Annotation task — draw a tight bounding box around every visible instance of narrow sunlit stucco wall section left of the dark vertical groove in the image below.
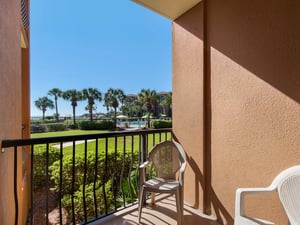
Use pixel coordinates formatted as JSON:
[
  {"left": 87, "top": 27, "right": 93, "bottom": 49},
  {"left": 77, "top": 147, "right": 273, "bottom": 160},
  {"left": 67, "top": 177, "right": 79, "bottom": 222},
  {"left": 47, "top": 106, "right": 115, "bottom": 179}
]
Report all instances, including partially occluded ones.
[{"left": 172, "top": 3, "right": 204, "bottom": 209}]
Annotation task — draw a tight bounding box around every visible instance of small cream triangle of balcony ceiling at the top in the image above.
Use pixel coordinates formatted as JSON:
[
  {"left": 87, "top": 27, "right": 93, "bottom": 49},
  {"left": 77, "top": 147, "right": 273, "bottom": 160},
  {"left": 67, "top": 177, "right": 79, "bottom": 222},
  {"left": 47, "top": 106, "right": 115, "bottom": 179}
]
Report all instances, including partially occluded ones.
[{"left": 132, "top": 0, "right": 202, "bottom": 20}]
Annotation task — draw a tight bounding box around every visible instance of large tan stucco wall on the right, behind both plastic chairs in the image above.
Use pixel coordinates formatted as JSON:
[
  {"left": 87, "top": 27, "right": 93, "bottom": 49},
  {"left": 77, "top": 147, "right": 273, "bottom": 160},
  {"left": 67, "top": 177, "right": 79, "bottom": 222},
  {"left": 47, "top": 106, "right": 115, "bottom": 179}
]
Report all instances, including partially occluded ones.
[{"left": 173, "top": 0, "right": 300, "bottom": 224}]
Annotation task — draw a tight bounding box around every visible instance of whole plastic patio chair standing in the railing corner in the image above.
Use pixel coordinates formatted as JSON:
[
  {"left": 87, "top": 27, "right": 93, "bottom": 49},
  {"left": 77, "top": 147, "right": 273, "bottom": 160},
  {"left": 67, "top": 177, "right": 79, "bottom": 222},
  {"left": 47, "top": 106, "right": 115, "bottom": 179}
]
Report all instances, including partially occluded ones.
[{"left": 138, "top": 141, "right": 186, "bottom": 224}]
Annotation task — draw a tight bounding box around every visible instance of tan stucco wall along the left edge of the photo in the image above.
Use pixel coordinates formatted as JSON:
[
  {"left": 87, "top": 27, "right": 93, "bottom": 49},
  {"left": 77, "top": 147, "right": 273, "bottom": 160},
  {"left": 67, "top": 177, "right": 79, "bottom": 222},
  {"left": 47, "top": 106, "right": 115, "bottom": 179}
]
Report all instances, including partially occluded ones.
[{"left": 0, "top": 0, "right": 30, "bottom": 224}]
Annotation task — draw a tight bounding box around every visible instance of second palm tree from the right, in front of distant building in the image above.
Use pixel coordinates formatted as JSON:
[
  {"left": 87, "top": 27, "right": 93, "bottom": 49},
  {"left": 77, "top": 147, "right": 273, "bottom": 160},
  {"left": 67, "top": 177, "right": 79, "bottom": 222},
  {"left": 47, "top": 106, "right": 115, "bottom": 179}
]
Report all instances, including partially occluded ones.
[{"left": 138, "top": 89, "right": 158, "bottom": 128}]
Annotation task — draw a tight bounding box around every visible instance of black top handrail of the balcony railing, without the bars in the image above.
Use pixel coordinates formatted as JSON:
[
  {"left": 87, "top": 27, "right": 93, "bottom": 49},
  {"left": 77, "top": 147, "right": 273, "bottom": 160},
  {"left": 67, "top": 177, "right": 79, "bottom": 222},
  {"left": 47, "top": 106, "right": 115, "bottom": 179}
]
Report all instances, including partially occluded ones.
[{"left": 1, "top": 128, "right": 172, "bottom": 149}]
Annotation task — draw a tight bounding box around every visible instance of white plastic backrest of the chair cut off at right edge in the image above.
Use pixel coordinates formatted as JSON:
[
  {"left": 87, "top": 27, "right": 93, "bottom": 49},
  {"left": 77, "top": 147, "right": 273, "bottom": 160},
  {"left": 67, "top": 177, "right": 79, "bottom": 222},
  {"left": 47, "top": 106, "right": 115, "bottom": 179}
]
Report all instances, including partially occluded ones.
[{"left": 275, "top": 166, "right": 300, "bottom": 225}]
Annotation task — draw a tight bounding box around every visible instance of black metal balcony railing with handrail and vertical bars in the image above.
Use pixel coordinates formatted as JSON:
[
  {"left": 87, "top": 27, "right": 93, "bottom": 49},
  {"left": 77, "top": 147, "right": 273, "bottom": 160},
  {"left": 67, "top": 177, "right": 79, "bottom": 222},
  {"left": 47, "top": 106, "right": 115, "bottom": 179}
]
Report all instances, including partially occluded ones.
[{"left": 1, "top": 128, "right": 172, "bottom": 225}]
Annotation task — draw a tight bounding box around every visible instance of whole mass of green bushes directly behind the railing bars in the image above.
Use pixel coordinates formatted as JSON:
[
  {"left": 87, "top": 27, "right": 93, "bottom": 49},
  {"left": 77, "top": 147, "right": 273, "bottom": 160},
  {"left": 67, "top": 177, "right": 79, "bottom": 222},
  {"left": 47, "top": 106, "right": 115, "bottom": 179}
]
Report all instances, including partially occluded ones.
[{"left": 34, "top": 145, "right": 138, "bottom": 222}]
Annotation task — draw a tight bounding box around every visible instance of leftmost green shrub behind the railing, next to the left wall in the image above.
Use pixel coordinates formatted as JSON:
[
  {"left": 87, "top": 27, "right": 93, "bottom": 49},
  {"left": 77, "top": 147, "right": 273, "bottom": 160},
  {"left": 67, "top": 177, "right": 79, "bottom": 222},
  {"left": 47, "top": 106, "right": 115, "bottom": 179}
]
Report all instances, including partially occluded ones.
[{"left": 33, "top": 145, "right": 60, "bottom": 190}]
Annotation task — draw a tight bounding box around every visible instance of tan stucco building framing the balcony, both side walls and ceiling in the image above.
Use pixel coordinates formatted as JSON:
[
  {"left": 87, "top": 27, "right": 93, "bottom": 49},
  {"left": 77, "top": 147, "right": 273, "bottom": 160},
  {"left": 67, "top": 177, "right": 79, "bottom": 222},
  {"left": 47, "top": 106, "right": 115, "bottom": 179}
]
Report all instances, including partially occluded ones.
[{"left": 0, "top": 0, "right": 300, "bottom": 225}]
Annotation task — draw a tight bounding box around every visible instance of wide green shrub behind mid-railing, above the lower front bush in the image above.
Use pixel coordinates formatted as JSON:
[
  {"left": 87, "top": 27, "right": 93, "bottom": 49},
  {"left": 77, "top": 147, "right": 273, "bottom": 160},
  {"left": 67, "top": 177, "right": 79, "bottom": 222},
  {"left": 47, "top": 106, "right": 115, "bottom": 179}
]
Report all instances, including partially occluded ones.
[{"left": 49, "top": 151, "right": 137, "bottom": 195}]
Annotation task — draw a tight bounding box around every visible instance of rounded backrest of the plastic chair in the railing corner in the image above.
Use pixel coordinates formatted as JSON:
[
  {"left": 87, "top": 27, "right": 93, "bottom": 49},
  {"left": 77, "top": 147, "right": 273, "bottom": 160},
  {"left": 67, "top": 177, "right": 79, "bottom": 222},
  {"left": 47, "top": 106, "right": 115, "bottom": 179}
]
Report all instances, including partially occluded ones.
[{"left": 148, "top": 141, "right": 186, "bottom": 179}]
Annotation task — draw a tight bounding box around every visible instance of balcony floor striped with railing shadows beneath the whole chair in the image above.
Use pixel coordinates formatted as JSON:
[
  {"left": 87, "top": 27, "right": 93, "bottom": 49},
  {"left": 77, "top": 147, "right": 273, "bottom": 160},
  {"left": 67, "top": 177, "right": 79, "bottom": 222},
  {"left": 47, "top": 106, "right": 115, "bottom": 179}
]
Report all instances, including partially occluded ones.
[{"left": 92, "top": 195, "right": 219, "bottom": 225}]
